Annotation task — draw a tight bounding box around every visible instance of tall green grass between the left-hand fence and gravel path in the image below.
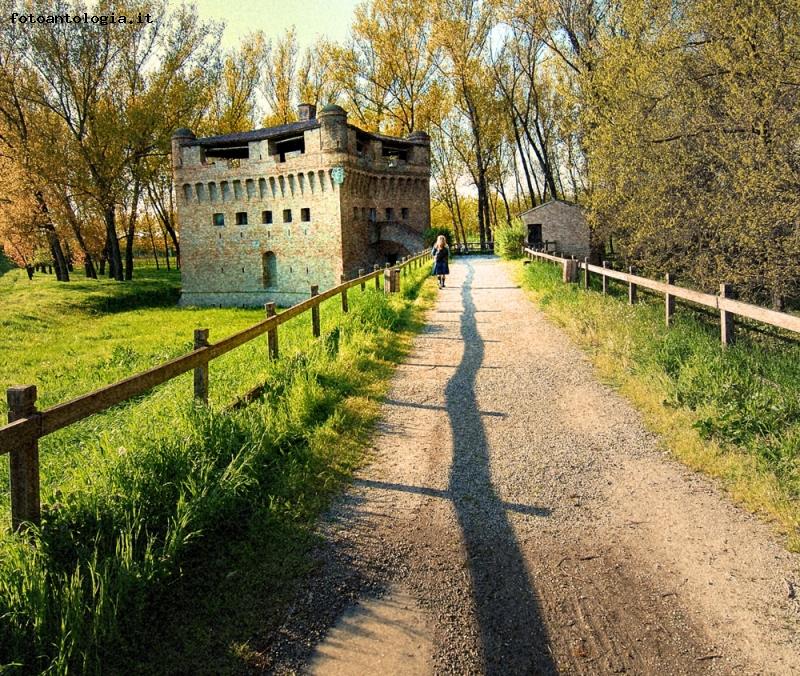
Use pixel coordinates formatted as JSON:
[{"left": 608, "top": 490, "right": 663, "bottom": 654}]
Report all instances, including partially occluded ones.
[{"left": 0, "top": 270, "right": 434, "bottom": 673}]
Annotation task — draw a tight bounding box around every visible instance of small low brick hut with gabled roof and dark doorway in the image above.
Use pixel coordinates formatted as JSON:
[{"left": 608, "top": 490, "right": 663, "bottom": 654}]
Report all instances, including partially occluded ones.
[{"left": 520, "top": 200, "right": 591, "bottom": 258}]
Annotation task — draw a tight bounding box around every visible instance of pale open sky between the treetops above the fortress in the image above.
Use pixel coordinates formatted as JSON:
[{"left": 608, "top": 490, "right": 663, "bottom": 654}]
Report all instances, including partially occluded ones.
[{"left": 184, "top": 0, "right": 358, "bottom": 51}]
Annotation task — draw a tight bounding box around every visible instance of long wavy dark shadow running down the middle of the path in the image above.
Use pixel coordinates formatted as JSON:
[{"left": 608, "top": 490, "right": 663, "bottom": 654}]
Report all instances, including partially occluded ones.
[{"left": 445, "top": 261, "right": 557, "bottom": 674}]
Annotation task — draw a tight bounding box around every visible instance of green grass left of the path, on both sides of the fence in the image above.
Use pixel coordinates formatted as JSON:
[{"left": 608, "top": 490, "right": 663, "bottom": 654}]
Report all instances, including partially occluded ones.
[{"left": 0, "top": 268, "right": 438, "bottom": 673}]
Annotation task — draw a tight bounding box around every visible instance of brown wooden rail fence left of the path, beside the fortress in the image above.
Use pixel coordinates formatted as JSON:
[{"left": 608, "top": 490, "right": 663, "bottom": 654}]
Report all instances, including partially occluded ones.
[{"left": 0, "top": 251, "right": 429, "bottom": 530}]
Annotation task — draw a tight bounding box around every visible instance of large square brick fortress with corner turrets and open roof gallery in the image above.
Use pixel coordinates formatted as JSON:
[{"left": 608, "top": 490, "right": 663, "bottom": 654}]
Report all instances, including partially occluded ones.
[{"left": 172, "top": 104, "right": 430, "bottom": 306}]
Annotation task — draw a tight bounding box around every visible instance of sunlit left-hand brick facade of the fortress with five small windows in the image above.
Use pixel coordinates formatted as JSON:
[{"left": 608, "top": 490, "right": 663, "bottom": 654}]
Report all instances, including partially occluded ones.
[{"left": 177, "top": 145, "right": 341, "bottom": 306}]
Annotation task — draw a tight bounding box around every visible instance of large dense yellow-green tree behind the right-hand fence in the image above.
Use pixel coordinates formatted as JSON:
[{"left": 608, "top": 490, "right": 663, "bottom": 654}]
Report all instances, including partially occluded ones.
[{"left": 583, "top": 0, "right": 800, "bottom": 304}]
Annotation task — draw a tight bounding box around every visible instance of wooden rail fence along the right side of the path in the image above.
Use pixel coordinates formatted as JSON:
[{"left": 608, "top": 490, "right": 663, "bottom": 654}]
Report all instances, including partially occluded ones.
[{"left": 523, "top": 248, "right": 800, "bottom": 346}]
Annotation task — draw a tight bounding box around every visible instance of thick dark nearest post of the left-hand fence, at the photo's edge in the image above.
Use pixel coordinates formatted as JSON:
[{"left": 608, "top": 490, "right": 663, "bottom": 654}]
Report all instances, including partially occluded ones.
[{"left": 6, "top": 385, "right": 41, "bottom": 532}]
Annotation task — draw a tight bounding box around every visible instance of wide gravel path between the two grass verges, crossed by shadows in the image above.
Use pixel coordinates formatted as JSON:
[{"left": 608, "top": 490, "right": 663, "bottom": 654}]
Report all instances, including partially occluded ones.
[{"left": 262, "top": 258, "right": 800, "bottom": 674}]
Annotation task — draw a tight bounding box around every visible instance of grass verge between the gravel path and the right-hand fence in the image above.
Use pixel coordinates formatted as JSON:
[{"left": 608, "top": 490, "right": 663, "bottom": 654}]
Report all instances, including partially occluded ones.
[{"left": 515, "top": 263, "right": 800, "bottom": 551}]
